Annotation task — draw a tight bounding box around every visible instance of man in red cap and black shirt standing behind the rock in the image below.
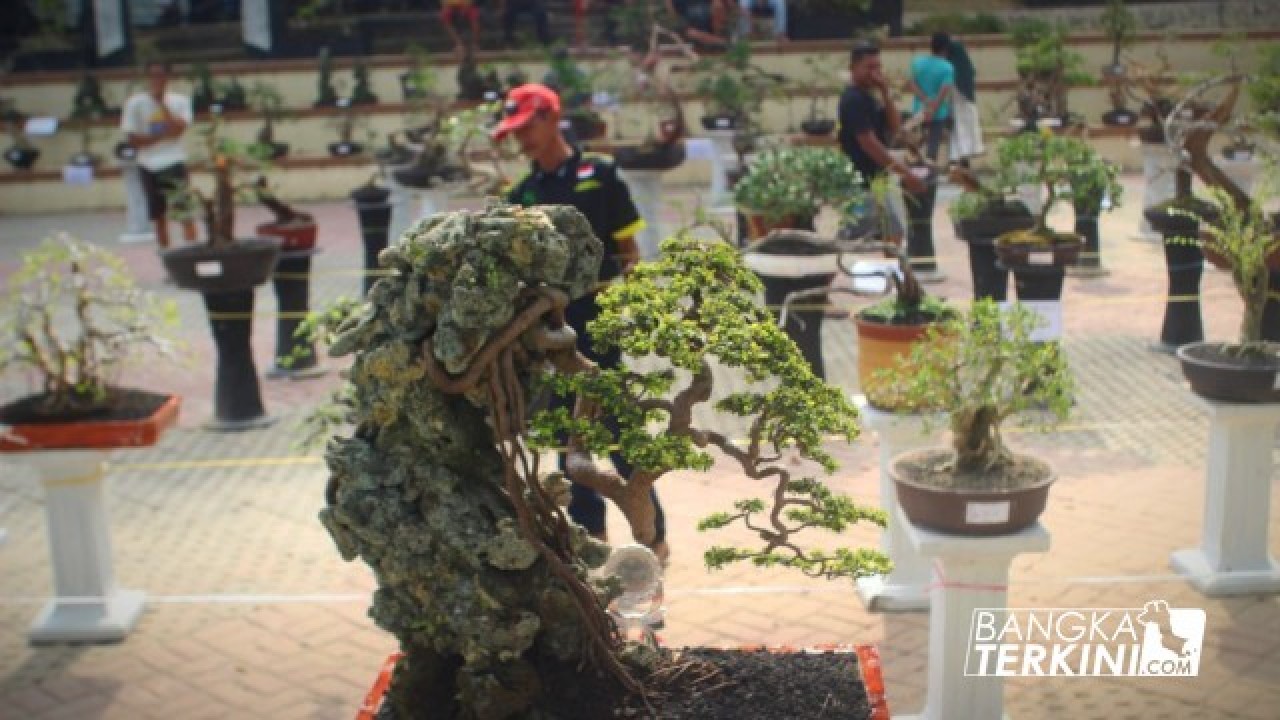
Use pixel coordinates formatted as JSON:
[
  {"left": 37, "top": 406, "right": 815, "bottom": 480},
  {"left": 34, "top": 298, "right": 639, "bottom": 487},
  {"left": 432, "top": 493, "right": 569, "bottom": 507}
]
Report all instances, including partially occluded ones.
[{"left": 493, "top": 83, "right": 669, "bottom": 562}]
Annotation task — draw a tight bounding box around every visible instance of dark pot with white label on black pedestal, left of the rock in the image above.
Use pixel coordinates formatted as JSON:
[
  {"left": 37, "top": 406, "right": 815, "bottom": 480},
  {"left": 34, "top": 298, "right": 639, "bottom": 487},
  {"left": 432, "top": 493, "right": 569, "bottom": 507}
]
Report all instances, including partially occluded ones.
[{"left": 160, "top": 237, "right": 280, "bottom": 292}]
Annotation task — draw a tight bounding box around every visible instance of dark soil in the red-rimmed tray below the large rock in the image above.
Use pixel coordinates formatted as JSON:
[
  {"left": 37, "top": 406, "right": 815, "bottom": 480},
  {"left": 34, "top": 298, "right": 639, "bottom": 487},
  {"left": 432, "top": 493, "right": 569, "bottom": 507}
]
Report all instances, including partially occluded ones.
[{"left": 376, "top": 648, "right": 870, "bottom": 720}]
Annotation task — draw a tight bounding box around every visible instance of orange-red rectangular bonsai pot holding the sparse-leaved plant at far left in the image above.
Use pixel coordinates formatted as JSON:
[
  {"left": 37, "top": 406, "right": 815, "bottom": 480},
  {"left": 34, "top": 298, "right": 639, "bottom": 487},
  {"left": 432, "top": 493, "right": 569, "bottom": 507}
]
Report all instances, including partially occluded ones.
[{"left": 0, "top": 388, "right": 182, "bottom": 452}]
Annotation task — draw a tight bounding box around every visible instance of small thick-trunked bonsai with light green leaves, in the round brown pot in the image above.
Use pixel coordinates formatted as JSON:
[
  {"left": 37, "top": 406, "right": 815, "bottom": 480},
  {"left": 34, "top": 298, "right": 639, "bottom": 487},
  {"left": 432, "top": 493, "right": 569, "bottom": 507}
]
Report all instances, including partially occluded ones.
[{"left": 883, "top": 299, "right": 1074, "bottom": 479}]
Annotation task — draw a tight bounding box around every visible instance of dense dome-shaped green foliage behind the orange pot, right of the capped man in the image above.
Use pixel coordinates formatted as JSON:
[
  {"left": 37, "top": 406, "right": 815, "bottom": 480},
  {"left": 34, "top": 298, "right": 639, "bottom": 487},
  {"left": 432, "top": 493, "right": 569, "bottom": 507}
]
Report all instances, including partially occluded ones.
[{"left": 733, "top": 147, "right": 863, "bottom": 227}]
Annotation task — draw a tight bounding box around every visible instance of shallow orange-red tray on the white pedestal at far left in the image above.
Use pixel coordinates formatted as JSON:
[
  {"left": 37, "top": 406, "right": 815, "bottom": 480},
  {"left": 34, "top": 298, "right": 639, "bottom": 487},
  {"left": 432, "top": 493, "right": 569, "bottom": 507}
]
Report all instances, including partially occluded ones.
[{"left": 0, "top": 391, "right": 182, "bottom": 452}]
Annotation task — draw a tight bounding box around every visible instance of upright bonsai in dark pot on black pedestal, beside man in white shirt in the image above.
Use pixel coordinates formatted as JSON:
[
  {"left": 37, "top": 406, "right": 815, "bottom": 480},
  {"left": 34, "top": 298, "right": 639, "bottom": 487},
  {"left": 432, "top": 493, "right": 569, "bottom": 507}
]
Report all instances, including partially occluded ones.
[{"left": 160, "top": 115, "right": 280, "bottom": 430}]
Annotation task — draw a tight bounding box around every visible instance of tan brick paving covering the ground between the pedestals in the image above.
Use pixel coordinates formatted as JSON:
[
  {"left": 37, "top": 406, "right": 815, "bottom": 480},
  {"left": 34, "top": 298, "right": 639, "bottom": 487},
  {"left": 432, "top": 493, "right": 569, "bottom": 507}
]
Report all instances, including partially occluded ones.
[{"left": 0, "top": 178, "right": 1280, "bottom": 720}]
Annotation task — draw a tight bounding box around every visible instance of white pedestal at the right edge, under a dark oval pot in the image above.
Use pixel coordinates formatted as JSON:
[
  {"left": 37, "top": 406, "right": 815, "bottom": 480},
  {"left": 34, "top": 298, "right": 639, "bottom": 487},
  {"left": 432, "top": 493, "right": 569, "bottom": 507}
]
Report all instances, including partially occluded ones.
[{"left": 1170, "top": 396, "right": 1280, "bottom": 596}]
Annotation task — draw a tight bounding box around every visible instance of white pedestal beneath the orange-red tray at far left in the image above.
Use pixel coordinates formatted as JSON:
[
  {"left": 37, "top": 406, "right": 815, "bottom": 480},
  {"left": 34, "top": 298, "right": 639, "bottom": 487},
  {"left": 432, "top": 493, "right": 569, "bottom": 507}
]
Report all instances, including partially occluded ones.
[{"left": 13, "top": 450, "right": 146, "bottom": 643}]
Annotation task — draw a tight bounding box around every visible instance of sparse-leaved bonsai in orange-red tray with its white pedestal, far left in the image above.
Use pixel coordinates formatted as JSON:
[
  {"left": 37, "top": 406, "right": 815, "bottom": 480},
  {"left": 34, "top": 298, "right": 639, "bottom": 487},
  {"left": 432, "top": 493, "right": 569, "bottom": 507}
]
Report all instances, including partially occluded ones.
[{"left": 0, "top": 234, "right": 180, "bottom": 643}]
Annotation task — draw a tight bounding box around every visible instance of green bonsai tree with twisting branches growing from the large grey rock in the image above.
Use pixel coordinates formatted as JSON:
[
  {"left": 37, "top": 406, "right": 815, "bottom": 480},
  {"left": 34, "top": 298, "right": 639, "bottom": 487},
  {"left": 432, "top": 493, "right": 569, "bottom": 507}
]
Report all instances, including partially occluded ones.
[{"left": 531, "top": 234, "right": 888, "bottom": 578}]
